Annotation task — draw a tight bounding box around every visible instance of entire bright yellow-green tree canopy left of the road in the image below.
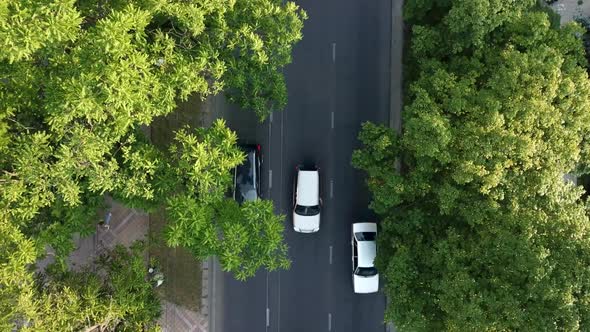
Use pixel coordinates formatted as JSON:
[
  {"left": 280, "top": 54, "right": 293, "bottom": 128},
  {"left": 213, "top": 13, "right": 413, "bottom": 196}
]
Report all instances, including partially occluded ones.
[{"left": 0, "top": 0, "right": 296, "bottom": 331}]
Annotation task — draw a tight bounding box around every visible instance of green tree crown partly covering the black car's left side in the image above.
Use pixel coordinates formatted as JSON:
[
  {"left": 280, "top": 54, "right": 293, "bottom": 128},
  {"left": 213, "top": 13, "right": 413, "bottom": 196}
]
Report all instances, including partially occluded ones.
[{"left": 166, "top": 120, "right": 290, "bottom": 280}]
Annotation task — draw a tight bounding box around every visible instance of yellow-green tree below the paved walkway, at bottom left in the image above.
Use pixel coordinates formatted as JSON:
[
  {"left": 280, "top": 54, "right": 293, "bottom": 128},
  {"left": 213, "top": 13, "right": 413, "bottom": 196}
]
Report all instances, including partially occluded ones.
[{"left": 27, "top": 242, "right": 161, "bottom": 331}]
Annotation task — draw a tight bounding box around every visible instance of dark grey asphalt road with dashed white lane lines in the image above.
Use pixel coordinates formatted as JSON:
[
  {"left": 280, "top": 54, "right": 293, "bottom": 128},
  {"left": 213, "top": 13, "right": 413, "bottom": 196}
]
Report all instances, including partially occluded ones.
[{"left": 220, "top": 0, "right": 392, "bottom": 332}]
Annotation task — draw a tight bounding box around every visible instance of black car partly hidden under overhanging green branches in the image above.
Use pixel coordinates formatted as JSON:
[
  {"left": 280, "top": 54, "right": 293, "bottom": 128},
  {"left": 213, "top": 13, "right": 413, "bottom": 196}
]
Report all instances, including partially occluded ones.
[{"left": 233, "top": 144, "right": 262, "bottom": 204}]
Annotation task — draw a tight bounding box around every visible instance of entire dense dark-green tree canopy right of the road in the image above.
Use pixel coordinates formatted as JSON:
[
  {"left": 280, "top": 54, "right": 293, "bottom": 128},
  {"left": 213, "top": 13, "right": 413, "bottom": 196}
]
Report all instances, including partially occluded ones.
[{"left": 353, "top": 1, "right": 590, "bottom": 331}]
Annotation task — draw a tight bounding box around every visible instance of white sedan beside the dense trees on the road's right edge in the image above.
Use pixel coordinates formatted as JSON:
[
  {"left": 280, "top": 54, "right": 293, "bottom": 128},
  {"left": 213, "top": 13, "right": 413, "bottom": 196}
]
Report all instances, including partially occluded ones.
[{"left": 351, "top": 222, "right": 379, "bottom": 294}]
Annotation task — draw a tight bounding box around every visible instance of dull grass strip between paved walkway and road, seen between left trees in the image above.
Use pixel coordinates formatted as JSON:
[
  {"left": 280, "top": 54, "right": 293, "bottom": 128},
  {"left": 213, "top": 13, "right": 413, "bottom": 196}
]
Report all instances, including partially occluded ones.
[{"left": 149, "top": 96, "right": 203, "bottom": 311}]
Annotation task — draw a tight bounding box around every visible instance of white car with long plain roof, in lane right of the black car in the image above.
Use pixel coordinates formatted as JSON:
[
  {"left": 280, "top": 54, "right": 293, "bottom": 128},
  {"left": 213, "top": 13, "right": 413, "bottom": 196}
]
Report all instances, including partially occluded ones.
[{"left": 293, "top": 167, "right": 322, "bottom": 233}]
